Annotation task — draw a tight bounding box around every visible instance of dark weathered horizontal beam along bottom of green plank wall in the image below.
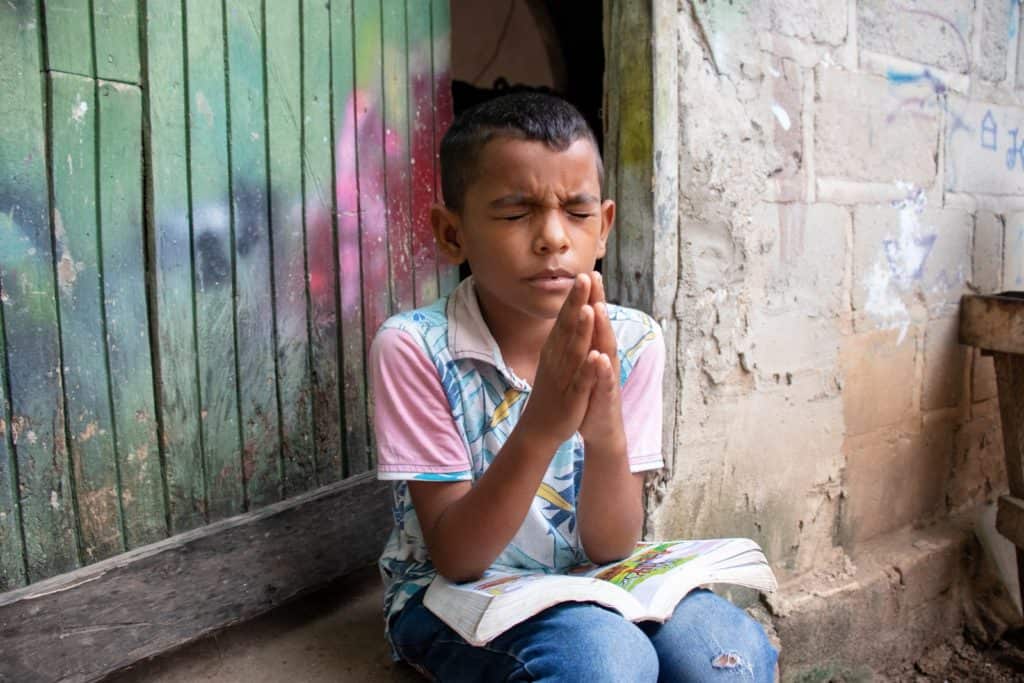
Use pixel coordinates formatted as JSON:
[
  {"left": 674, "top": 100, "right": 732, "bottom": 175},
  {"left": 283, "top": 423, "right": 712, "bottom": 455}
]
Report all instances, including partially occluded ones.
[{"left": 0, "top": 474, "right": 391, "bottom": 683}]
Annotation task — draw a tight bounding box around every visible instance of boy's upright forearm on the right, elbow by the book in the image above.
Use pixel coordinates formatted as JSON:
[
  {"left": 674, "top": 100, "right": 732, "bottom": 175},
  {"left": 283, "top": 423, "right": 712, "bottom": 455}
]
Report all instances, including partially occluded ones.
[{"left": 577, "top": 437, "right": 643, "bottom": 564}]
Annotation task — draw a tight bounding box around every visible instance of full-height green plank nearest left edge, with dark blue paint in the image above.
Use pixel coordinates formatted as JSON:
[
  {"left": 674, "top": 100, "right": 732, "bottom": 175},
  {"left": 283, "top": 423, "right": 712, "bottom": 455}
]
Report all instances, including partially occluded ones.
[{"left": 0, "top": 2, "right": 79, "bottom": 582}]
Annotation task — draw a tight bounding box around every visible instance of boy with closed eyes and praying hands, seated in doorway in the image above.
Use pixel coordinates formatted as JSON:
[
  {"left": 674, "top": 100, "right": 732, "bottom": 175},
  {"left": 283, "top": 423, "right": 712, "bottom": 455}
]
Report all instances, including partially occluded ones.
[{"left": 371, "top": 93, "right": 775, "bottom": 683}]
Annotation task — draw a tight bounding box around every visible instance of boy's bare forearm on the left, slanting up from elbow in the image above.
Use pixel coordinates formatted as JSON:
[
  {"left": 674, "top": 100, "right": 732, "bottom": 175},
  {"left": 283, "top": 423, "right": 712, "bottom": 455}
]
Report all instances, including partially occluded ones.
[{"left": 414, "top": 423, "right": 558, "bottom": 581}]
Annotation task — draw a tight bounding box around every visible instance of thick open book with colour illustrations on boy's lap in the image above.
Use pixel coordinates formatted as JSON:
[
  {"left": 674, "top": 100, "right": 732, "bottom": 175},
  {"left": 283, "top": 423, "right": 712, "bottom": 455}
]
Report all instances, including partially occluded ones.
[{"left": 423, "top": 539, "right": 776, "bottom": 645}]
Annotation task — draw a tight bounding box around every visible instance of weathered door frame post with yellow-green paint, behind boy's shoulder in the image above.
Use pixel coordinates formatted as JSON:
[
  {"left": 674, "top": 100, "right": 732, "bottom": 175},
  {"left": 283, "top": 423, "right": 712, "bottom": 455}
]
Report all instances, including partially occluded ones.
[{"left": 604, "top": 0, "right": 682, "bottom": 518}]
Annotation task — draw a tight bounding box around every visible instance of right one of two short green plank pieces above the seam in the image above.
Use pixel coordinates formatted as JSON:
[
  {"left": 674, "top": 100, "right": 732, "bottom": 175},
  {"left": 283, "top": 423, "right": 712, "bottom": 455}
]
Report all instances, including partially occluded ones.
[{"left": 92, "top": 0, "right": 140, "bottom": 83}]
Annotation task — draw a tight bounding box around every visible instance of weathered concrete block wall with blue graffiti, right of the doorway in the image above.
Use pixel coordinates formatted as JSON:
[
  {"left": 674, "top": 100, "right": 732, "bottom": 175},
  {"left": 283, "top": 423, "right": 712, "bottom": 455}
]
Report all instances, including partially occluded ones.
[{"left": 650, "top": 0, "right": 1024, "bottom": 580}]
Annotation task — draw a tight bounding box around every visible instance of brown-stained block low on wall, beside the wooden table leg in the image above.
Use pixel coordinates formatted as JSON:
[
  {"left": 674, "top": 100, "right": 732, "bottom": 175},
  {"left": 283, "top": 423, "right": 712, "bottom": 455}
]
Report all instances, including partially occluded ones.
[{"left": 947, "top": 415, "right": 1007, "bottom": 510}]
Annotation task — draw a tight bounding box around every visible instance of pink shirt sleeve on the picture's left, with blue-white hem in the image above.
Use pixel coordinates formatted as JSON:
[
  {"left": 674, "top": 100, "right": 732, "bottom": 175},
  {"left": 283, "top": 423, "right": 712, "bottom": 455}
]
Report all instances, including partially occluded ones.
[{"left": 370, "top": 329, "right": 472, "bottom": 481}]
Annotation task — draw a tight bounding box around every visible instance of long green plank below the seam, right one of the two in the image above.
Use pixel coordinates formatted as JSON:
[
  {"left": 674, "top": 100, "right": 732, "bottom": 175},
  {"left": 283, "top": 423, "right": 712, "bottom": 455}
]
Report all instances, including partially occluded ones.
[{"left": 99, "top": 82, "right": 168, "bottom": 548}]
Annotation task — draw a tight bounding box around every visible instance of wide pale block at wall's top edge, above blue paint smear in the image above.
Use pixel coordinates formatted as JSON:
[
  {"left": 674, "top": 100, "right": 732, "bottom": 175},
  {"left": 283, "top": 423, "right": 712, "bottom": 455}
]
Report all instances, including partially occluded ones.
[{"left": 857, "top": 0, "right": 974, "bottom": 74}]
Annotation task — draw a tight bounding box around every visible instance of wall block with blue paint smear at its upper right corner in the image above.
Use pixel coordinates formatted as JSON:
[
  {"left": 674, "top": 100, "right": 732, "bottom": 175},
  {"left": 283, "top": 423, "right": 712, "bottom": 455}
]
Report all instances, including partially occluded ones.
[{"left": 814, "top": 68, "right": 940, "bottom": 187}]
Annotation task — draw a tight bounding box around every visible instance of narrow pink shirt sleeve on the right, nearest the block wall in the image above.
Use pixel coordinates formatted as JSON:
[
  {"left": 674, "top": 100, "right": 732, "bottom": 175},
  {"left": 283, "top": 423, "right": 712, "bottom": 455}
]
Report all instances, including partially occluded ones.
[{"left": 623, "top": 335, "right": 665, "bottom": 472}]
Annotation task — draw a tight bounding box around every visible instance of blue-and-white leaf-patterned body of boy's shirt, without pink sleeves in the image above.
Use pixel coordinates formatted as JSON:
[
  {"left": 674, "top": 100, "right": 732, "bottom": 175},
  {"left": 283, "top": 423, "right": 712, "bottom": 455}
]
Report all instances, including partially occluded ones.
[{"left": 378, "top": 278, "right": 662, "bottom": 634}]
